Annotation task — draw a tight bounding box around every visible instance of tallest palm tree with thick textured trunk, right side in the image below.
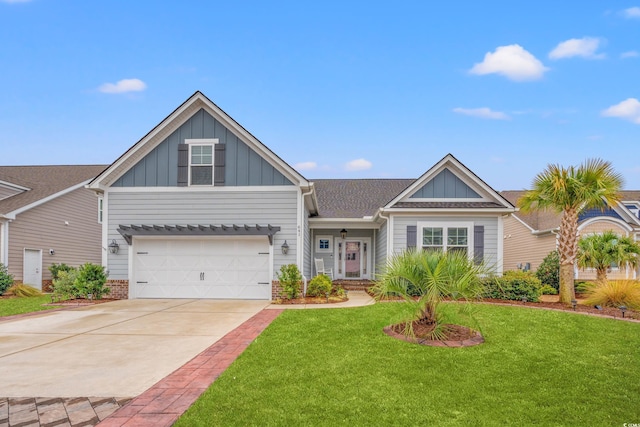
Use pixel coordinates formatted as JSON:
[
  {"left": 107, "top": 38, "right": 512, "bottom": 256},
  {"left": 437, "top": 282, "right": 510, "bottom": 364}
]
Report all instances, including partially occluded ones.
[{"left": 518, "top": 159, "right": 623, "bottom": 304}]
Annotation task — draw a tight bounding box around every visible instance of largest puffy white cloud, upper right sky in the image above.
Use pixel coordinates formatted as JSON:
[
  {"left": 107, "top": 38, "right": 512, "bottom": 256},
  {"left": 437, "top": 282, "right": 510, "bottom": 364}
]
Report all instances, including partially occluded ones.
[{"left": 469, "top": 44, "right": 549, "bottom": 81}]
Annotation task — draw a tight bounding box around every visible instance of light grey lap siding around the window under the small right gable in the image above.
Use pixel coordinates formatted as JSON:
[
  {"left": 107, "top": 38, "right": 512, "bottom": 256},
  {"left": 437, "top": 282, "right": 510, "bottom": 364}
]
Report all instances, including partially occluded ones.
[{"left": 393, "top": 215, "right": 502, "bottom": 265}]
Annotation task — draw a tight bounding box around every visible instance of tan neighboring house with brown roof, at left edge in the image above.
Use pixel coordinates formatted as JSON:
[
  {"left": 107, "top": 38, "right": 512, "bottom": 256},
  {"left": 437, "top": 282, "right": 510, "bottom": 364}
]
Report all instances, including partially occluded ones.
[{"left": 0, "top": 165, "right": 106, "bottom": 289}]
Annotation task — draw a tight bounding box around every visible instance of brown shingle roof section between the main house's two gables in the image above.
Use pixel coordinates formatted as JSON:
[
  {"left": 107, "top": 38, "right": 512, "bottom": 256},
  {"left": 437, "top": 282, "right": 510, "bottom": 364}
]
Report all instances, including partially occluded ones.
[{"left": 310, "top": 179, "right": 415, "bottom": 218}]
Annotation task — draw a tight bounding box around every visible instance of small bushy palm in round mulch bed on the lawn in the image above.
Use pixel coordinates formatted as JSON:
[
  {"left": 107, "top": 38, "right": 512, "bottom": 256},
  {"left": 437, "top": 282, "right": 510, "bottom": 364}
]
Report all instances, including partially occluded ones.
[{"left": 374, "top": 250, "right": 486, "bottom": 339}]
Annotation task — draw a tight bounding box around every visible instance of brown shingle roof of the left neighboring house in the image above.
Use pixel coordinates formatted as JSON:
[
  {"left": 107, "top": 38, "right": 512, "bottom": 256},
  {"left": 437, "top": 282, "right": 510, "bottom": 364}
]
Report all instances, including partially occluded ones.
[{"left": 0, "top": 165, "right": 107, "bottom": 215}]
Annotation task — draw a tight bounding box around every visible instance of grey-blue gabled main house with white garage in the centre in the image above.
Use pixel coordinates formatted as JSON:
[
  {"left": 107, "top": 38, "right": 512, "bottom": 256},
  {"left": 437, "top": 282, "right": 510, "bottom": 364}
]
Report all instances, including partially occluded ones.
[{"left": 88, "top": 92, "right": 514, "bottom": 299}]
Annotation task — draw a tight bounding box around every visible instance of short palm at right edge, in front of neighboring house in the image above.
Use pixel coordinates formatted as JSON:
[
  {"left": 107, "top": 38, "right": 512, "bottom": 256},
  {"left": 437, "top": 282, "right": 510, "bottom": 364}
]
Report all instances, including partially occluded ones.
[{"left": 577, "top": 230, "right": 640, "bottom": 281}]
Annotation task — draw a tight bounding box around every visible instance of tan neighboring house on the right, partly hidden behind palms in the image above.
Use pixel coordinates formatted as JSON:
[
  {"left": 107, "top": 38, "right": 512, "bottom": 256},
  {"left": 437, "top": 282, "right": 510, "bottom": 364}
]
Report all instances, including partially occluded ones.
[{"left": 500, "top": 191, "right": 640, "bottom": 280}]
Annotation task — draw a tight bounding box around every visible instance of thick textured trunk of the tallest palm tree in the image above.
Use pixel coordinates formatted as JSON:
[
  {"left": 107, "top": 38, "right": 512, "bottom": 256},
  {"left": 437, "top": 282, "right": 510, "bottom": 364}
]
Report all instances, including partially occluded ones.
[{"left": 558, "top": 207, "right": 578, "bottom": 304}]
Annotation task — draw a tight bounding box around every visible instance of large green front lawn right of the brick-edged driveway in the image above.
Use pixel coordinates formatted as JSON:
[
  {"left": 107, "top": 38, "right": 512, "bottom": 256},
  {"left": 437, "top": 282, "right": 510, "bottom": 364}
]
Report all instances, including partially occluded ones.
[{"left": 176, "top": 303, "right": 640, "bottom": 426}]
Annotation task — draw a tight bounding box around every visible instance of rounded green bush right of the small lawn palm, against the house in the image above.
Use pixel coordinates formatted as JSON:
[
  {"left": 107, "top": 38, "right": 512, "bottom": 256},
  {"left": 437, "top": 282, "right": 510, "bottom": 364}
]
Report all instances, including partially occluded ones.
[{"left": 482, "top": 270, "right": 542, "bottom": 302}]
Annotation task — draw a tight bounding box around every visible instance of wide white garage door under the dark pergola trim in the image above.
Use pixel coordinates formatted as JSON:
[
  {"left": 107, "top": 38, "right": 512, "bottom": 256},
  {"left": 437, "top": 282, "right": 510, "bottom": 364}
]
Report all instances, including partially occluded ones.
[{"left": 131, "top": 236, "right": 271, "bottom": 299}]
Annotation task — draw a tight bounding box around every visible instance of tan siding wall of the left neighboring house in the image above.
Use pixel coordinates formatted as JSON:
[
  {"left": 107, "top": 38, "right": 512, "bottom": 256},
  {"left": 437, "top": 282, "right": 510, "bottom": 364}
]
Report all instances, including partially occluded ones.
[{"left": 9, "top": 188, "right": 102, "bottom": 280}]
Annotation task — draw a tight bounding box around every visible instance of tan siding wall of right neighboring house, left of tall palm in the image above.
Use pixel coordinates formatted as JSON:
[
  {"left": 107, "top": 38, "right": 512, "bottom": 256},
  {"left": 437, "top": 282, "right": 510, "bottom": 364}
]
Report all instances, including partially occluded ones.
[{"left": 503, "top": 216, "right": 556, "bottom": 271}]
